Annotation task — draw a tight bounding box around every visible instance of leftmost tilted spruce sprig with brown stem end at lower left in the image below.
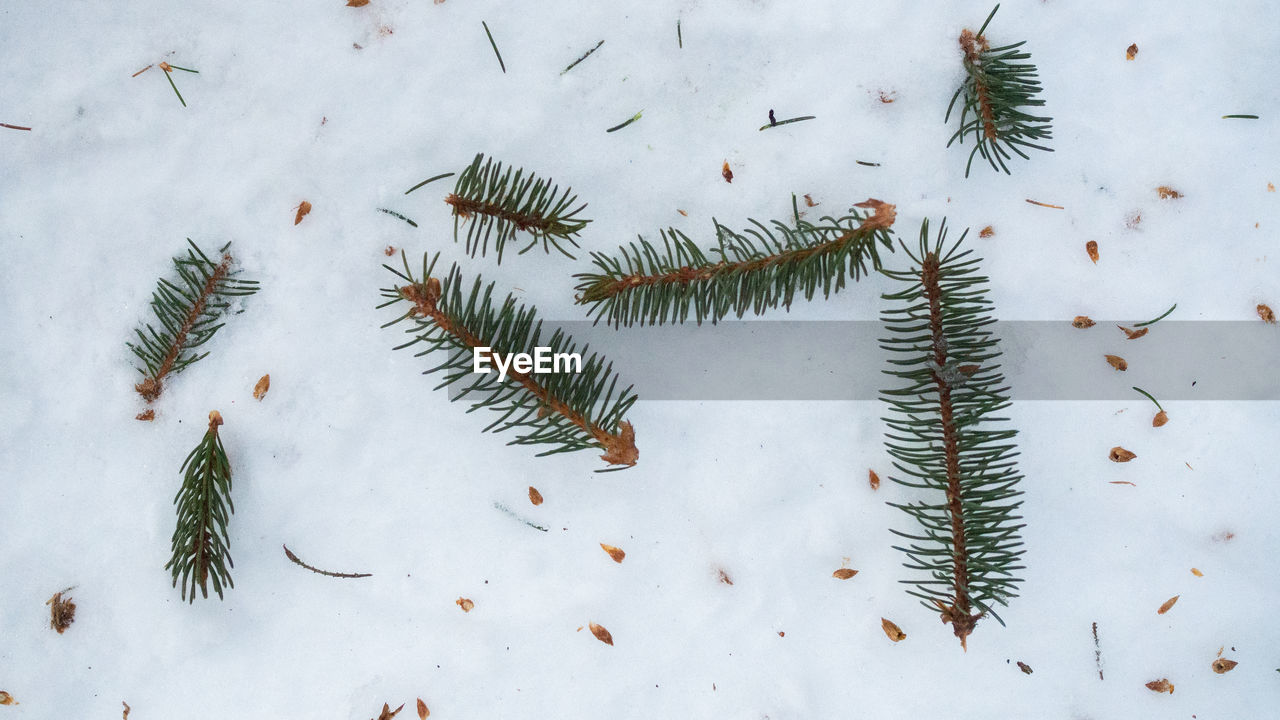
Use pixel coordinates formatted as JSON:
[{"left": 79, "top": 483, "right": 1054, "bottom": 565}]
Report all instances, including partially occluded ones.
[{"left": 125, "top": 238, "right": 257, "bottom": 402}]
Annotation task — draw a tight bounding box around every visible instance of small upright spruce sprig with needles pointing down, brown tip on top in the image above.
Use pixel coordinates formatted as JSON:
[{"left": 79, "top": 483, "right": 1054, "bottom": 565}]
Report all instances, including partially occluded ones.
[{"left": 164, "top": 410, "right": 236, "bottom": 602}]
